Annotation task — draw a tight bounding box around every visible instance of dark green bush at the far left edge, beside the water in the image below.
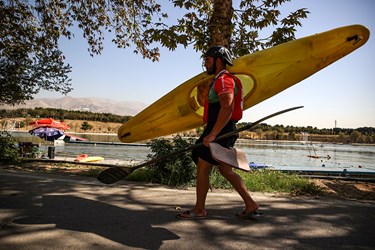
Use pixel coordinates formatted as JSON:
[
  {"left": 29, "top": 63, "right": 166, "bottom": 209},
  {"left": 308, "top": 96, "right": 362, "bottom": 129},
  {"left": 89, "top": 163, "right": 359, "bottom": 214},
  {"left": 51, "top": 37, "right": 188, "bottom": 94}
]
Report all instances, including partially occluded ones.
[{"left": 0, "top": 131, "right": 19, "bottom": 163}]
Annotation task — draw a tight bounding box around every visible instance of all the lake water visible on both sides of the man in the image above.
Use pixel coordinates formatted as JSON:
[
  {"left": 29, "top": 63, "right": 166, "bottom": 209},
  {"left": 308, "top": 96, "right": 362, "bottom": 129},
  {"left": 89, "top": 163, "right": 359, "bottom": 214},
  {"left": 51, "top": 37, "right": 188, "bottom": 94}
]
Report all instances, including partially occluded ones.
[{"left": 9, "top": 133, "right": 375, "bottom": 170}]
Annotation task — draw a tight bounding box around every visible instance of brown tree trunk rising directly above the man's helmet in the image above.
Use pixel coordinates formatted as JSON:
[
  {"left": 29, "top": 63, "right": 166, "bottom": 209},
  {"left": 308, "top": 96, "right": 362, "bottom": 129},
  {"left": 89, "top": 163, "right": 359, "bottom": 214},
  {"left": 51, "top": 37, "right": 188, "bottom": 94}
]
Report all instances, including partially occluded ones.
[{"left": 208, "top": 0, "right": 233, "bottom": 48}]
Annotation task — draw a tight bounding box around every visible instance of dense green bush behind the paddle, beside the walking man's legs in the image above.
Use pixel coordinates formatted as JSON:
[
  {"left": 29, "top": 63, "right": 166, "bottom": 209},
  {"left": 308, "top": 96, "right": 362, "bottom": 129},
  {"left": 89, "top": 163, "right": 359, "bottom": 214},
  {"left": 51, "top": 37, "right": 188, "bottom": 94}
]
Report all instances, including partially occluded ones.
[{"left": 148, "top": 136, "right": 196, "bottom": 187}]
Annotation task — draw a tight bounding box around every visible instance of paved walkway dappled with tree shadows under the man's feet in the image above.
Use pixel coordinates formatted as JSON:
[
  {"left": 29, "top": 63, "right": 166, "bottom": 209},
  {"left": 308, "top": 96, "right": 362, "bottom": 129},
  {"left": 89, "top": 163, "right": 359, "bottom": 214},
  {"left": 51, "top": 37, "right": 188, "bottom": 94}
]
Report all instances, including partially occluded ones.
[{"left": 0, "top": 169, "right": 375, "bottom": 250}]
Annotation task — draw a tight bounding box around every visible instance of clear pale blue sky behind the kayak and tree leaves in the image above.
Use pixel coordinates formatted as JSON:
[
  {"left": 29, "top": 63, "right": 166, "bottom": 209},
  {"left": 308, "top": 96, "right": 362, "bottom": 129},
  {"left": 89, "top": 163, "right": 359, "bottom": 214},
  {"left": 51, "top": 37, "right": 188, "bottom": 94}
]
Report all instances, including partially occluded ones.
[{"left": 36, "top": 0, "right": 375, "bottom": 128}]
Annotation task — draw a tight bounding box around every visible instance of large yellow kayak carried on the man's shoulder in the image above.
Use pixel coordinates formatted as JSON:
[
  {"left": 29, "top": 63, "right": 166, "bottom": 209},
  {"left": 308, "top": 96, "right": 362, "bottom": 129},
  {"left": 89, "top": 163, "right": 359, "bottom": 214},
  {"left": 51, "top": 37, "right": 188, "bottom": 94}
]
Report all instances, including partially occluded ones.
[{"left": 118, "top": 25, "right": 370, "bottom": 143}]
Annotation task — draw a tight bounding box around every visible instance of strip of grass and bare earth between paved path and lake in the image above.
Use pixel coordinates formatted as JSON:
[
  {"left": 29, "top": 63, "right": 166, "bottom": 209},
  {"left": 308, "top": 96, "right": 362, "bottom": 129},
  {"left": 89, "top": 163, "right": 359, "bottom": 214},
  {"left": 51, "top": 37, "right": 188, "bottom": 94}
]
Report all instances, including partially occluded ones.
[{"left": 0, "top": 162, "right": 375, "bottom": 201}]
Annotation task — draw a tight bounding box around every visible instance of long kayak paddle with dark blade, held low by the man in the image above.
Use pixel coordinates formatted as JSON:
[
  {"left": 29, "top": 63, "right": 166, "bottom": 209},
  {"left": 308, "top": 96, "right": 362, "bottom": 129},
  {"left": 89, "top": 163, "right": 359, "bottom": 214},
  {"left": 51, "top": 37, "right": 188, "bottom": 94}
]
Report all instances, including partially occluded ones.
[{"left": 96, "top": 106, "right": 303, "bottom": 184}]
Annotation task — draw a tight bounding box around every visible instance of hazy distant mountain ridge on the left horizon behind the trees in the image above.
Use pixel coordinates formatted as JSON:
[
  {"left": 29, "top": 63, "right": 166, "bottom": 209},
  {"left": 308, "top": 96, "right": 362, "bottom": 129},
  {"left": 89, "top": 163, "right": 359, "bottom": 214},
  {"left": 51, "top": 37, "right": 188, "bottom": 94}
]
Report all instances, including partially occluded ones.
[{"left": 0, "top": 96, "right": 148, "bottom": 116}]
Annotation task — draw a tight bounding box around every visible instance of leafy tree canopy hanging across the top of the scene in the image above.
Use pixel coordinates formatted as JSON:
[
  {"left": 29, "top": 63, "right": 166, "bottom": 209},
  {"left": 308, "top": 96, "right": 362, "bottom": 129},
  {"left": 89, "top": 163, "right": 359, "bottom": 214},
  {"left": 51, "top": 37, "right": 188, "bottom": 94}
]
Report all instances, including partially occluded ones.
[{"left": 0, "top": 0, "right": 308, "bottom": 105}]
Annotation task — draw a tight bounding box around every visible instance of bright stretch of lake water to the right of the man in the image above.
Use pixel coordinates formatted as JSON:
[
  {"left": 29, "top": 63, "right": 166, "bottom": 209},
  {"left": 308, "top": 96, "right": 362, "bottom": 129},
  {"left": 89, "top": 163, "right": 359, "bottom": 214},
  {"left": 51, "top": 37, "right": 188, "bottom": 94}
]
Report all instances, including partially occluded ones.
[{"left": 237, "top": 141, "right": 375, "bottom": 170}]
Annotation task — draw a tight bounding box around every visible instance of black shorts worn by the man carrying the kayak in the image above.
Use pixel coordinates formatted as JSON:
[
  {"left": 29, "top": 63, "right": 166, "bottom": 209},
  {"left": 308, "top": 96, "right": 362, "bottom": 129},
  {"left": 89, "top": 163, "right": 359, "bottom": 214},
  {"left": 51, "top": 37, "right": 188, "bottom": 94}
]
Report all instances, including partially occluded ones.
[{"left": 192, "top": 121, "right": 238, "bottom": 165}]
